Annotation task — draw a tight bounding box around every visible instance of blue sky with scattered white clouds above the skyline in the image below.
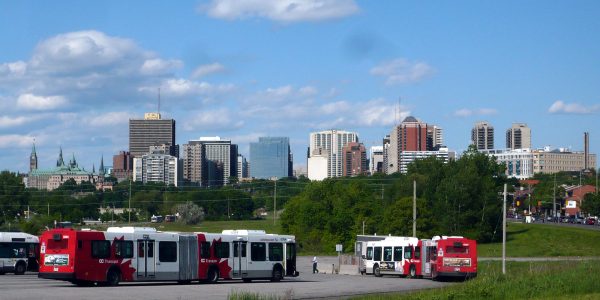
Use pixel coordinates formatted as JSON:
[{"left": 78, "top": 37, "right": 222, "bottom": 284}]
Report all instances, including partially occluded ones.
[{"left": 0, "top": 0, "right": 600, "bottom": 172}]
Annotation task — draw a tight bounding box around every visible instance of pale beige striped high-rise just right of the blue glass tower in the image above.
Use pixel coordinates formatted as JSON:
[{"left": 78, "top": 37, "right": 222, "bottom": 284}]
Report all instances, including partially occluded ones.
[{"left": 310, "top": 130, "right": 358, "bottom": 179}]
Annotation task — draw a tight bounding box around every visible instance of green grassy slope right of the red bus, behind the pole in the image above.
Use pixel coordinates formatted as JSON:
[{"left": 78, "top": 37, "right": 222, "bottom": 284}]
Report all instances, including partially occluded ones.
[{"left": 477, "top": 223, "right": 600, "bottom": 257}]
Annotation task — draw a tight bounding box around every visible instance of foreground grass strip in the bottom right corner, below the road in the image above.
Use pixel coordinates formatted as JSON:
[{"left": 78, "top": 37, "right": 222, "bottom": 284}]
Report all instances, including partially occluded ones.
[{"left": 356, "top": 261, "right": 600, "bottom": 300}]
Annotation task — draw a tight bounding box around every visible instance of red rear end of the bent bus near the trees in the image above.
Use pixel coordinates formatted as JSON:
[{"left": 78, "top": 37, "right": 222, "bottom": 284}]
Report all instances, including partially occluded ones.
[{"left": 432, "top": 237, "right": 477, "bottom": 278}]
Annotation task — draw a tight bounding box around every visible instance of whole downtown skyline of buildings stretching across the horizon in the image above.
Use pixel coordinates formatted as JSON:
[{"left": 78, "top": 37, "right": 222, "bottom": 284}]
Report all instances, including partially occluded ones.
[{"left": 24, "top": 113, "right": 596, "bottom": 190}]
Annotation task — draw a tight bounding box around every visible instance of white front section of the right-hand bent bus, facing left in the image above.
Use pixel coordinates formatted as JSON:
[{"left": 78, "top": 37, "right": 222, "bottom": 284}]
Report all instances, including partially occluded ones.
[{"left": 363, "top": 236, "right": 421, "bottom": 277}]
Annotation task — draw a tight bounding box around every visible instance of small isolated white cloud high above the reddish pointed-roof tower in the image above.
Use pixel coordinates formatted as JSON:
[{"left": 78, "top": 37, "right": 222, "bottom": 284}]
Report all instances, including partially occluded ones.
[{"left": 369, "top": 58, "right": 435, "bottom": 85}]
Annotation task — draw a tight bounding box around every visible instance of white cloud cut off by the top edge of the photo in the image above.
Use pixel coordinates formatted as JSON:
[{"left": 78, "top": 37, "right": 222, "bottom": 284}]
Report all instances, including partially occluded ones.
[{"left": 201, "top": 0, "right": 359, "bottom": 23}]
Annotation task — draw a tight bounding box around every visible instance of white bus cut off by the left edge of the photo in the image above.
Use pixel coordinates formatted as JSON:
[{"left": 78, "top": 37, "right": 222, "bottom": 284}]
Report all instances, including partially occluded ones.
[{"left": 0, "top": 232, "right": 39, "bottom": 275}]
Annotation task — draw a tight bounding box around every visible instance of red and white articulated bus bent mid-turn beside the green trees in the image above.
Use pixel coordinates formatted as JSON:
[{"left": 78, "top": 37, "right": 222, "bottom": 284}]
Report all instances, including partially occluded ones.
[{"left": 361, "top": 236, "right": 477, "bottom": 280}]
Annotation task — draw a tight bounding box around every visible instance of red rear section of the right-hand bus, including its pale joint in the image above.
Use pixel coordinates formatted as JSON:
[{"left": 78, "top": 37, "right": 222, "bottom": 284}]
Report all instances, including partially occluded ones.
[{"left": 421, "top": 236, "right": 477, "bottom": 279}]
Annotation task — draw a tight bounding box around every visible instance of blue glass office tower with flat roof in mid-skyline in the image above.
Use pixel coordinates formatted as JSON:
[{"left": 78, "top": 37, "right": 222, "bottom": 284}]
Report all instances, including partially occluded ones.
[{"left": 250, "top": 137, "right": 293, "bottom": 179}]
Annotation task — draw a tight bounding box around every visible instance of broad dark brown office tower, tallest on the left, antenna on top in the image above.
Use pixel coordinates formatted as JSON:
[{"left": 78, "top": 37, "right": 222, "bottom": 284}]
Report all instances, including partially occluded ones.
[{"left": 129, "top": 113, "right": 179, "bottom": 157}]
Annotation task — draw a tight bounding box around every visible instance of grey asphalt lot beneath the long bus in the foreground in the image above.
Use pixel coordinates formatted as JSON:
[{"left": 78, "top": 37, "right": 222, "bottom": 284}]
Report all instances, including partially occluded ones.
[{"left": 0, "top": 257, "right": 450, "bottom": 300}]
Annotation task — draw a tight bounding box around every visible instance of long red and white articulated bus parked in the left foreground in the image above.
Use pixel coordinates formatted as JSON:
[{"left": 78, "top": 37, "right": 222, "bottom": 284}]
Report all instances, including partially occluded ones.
[{"left": 38, "top": 227, "right": 298, "bottom": 285}]
